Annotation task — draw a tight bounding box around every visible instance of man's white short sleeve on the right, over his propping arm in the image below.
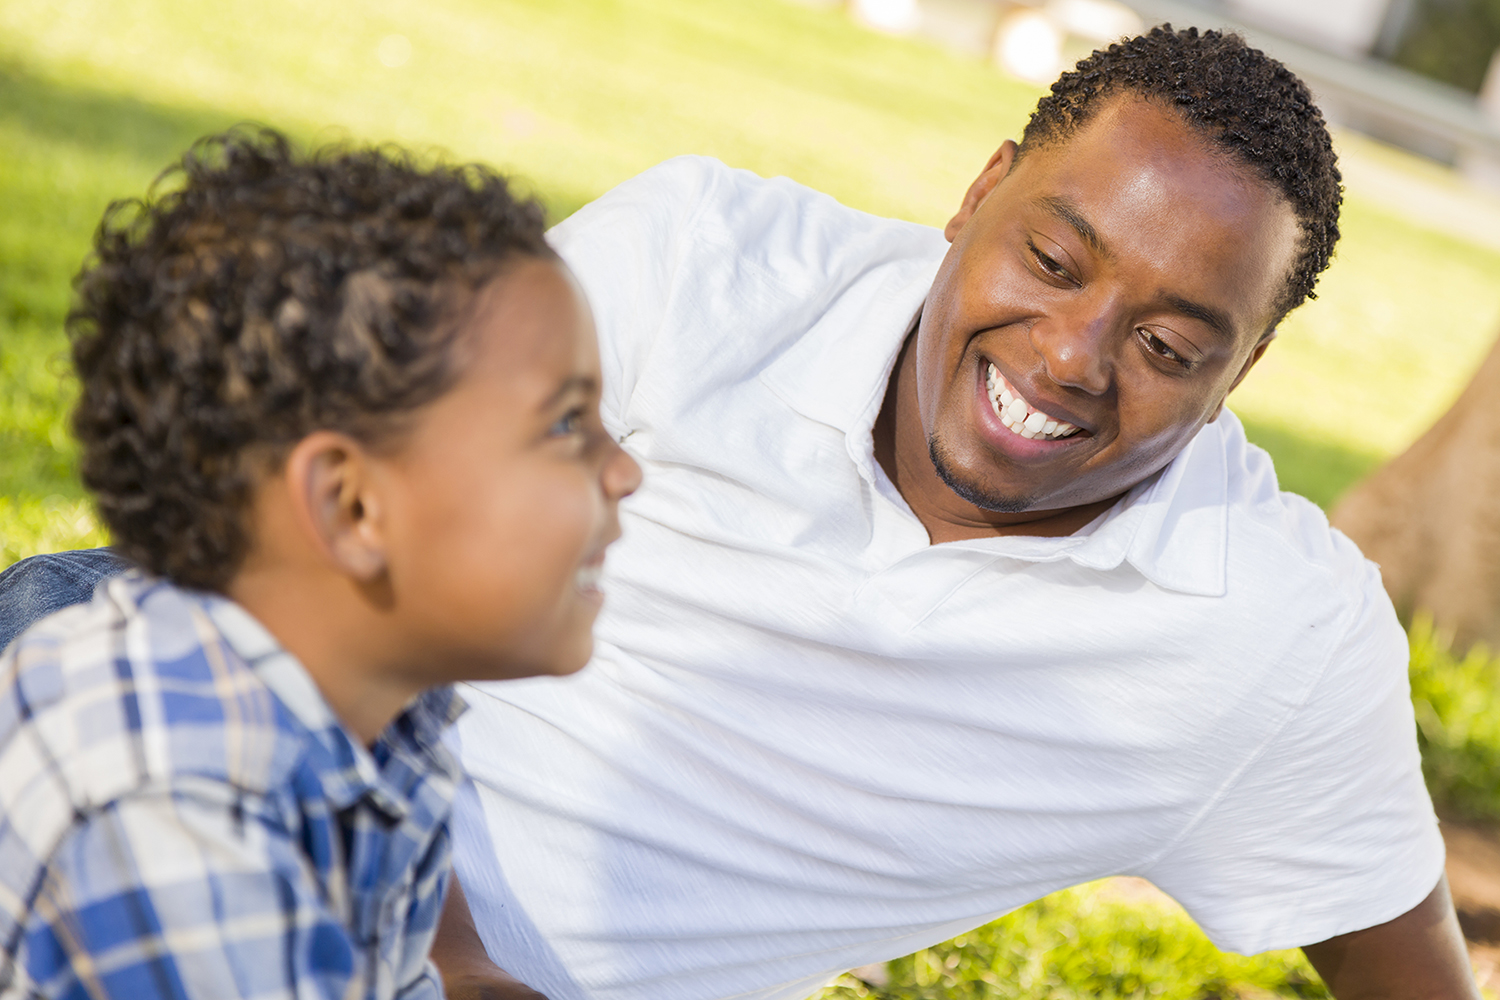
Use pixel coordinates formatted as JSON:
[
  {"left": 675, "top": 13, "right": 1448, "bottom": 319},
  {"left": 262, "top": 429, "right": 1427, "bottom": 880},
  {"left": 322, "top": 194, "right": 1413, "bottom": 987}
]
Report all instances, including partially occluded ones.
[{"left": 1143, "top": 560, "right": 1445, "bottom": 954}]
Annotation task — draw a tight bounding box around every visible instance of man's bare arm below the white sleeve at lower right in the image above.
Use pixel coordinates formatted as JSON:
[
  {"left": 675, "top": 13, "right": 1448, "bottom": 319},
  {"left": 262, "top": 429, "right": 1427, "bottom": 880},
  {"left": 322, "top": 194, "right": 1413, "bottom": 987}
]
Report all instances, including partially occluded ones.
[{"left": 1302, "top": 876, "right": 1479, "bottom": 1000}]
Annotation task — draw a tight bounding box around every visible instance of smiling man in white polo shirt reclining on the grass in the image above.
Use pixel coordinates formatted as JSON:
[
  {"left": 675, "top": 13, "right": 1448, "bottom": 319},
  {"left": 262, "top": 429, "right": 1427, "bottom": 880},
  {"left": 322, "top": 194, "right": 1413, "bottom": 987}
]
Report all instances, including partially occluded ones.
[{"left": 0, "top": 28, "right": 1478, "bottom": 1000}]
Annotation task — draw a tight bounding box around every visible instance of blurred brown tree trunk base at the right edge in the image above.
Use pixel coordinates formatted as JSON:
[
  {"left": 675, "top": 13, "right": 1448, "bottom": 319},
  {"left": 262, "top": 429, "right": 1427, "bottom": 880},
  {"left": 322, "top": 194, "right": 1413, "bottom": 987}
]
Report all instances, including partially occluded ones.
[{"left": 1332, "top": 332, "right": 1500, "bottom": 651}]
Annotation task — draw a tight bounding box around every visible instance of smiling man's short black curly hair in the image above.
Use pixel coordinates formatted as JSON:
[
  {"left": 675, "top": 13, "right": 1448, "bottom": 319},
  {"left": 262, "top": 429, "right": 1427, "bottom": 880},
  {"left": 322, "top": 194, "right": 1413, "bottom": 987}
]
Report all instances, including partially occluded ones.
[{"left": 1022, "top": 24, "right": 1343, "bottom": 322}]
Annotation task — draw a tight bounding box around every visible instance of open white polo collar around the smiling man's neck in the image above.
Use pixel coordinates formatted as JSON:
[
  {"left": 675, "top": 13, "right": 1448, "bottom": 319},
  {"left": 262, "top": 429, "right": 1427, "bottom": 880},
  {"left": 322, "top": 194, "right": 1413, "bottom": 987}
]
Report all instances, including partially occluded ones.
[{"left": 761, "top": 255, "right": 1244, "bottom": 597}]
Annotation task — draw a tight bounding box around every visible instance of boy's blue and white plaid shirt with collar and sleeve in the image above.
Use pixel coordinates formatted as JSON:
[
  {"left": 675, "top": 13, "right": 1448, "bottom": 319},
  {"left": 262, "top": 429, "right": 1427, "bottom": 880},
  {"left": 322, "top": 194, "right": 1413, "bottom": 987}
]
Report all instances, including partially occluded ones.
[{"left": 0, "top": 573, "right": 464, "bottom": 999}]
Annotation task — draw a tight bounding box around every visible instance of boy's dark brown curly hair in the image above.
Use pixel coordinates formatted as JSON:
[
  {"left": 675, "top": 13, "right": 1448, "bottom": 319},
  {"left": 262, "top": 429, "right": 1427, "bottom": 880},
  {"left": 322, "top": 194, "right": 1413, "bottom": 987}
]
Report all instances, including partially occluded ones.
[{"left": 68, "top": 127, "right": 554, "bottom": 589}]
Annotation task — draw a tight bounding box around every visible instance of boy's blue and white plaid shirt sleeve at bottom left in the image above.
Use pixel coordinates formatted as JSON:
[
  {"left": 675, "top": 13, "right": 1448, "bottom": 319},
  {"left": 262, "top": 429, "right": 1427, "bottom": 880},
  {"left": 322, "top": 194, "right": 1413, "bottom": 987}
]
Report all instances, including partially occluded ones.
[{"left": 18, "top": 789, "right": 366, "bottom": 1000}]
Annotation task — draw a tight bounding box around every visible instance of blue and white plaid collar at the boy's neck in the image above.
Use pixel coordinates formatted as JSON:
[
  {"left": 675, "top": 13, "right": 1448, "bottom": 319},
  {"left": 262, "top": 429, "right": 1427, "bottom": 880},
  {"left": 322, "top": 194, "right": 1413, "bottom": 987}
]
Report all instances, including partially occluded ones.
[{"left": 203, "top": 594, "right": 468, "bottom": 820}]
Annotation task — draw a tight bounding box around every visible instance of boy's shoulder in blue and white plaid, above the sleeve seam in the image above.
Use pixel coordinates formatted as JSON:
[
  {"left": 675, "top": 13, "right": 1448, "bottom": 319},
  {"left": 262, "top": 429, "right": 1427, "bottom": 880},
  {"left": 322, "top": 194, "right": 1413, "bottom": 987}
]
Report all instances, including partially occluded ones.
[{"left": 0, "top": 574, "right": 305, "bottom": 840}]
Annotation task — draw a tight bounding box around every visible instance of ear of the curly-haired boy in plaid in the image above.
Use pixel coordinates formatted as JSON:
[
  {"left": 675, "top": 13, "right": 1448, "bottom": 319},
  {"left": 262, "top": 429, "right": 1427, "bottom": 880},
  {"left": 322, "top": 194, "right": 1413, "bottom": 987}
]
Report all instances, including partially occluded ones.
[{"left": 285, "top": 430, "right": 386, "bottom": 583}]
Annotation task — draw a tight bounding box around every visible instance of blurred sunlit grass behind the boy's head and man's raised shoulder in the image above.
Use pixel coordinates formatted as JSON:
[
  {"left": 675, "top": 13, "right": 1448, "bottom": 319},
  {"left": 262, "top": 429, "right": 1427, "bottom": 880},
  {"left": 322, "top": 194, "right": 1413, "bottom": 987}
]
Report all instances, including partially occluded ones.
[{"left": 0, "top": 0, "right": 1037, "bottom": 554}]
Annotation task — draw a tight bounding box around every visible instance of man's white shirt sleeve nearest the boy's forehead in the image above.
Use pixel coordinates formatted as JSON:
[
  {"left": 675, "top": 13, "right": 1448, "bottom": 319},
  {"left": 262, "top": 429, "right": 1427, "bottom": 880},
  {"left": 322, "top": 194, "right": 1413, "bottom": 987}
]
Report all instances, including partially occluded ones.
[{"left": 548, "top": 156, "right": 729, "bottom": 433}]
